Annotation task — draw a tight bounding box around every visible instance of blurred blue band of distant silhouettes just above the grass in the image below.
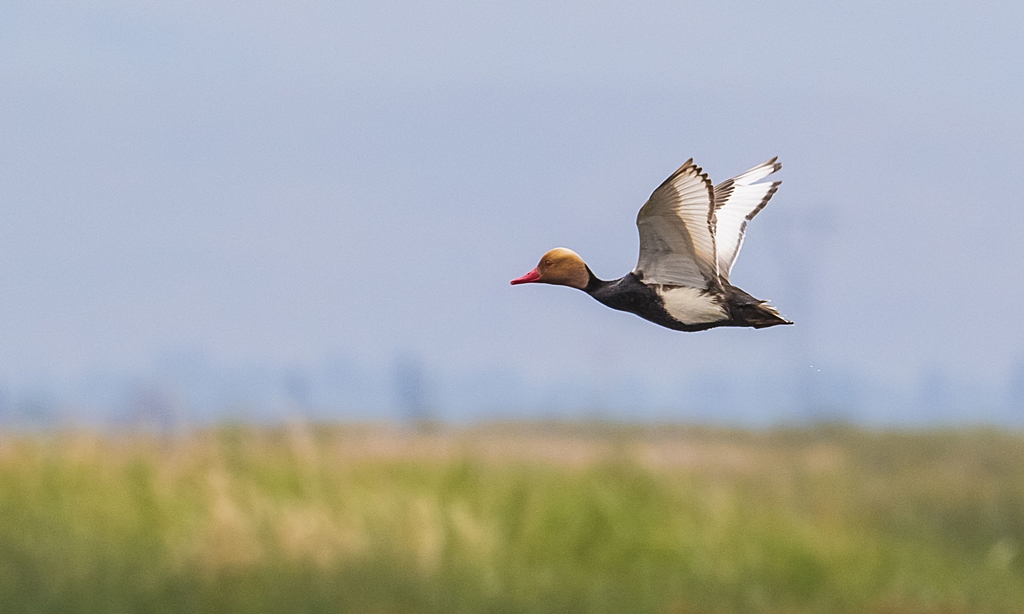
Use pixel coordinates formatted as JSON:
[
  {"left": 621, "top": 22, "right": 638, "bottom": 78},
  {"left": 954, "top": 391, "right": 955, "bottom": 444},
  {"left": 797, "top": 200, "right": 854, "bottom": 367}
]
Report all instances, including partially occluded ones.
[{"left": 0, "top": 352, "right": 1024, "bottom": 428}]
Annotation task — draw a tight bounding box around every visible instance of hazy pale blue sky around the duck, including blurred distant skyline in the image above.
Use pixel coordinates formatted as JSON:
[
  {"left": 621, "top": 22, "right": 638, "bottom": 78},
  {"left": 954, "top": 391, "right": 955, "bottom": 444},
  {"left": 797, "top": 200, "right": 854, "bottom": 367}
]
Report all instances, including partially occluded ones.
[{"left": 0, "top": 0, "right": 1024, "bottom": 425}]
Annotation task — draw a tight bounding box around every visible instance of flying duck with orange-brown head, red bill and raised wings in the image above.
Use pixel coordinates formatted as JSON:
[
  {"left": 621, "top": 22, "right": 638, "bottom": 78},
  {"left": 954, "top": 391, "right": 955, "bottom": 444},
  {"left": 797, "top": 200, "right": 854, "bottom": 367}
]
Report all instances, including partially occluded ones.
[{"left": 512, "top": 158, "right": 793, "bottom": 332}]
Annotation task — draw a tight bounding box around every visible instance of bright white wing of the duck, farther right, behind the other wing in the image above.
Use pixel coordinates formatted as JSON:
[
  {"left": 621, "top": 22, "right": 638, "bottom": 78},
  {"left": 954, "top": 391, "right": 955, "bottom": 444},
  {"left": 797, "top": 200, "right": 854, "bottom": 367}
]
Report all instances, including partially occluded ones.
[{"left": 715, "top": 157, "right": 782, "bottom": 281}]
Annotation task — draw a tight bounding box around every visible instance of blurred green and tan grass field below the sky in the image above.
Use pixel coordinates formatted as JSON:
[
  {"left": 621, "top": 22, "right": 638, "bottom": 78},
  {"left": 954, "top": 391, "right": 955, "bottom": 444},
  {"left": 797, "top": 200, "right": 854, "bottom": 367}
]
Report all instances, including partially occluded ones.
[{"left": 0, "top": 425, "right": 1024, "bottom": 614}]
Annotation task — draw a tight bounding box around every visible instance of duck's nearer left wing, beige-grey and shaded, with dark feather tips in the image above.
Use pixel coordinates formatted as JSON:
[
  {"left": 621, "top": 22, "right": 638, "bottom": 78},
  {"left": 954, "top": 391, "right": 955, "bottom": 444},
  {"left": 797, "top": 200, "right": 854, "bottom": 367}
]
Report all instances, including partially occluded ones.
[{"left": 633, "top": 159, "right": 721, "bottom": 290}]
